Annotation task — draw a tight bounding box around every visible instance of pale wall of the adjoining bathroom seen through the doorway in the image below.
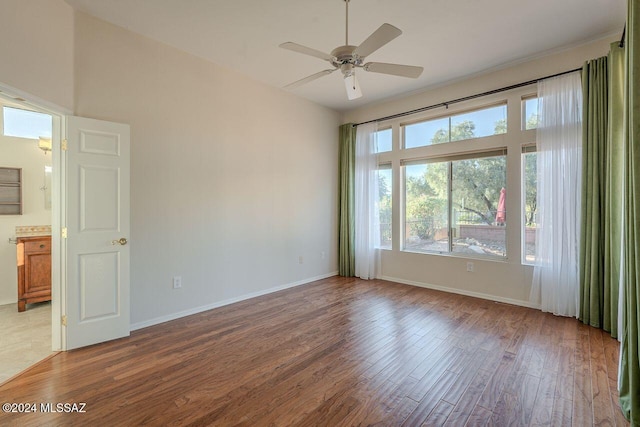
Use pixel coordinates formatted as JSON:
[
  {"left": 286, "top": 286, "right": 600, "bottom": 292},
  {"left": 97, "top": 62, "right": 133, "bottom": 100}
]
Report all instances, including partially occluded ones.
[{"left": 0, "top": 103, "right": 51, "bottom": 305}]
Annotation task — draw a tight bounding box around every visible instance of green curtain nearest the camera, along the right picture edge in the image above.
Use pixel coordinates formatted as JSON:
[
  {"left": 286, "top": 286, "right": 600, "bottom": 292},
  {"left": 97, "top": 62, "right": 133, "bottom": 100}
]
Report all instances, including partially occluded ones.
[{"left": 619, "top": 0, "right": 640, "bottom": 426}]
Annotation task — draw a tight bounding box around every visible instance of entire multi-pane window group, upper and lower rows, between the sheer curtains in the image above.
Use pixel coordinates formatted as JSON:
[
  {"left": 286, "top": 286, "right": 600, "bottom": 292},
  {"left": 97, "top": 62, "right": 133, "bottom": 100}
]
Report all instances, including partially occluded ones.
[{"left": 376, "top": 95, "right": 538, "bottom": 264}]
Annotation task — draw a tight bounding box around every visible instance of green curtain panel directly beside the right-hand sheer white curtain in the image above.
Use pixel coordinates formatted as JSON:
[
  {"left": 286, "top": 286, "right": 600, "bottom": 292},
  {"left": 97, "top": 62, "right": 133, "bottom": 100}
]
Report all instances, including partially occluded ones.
[{"left": 579, "top": 56, "right": 617, "bottom": 331}]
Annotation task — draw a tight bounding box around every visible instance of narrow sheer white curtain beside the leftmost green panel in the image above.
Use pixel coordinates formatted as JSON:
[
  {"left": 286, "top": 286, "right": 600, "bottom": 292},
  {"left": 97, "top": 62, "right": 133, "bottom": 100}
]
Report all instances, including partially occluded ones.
[{"left": 354, "top": 123, "right": 380, "bottom": 279}]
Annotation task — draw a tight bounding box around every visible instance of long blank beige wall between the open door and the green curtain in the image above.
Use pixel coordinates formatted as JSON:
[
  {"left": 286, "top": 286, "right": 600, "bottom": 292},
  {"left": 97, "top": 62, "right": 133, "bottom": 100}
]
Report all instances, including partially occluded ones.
[{"left": 75, "top": 13, "right": 339, "bottom": 326}]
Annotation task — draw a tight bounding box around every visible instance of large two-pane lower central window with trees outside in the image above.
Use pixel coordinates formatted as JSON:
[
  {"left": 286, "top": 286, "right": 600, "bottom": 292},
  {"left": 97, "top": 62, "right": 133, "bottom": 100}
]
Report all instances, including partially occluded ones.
[{"left": 404, "top": 150, "right": 507, "bottom": 258}]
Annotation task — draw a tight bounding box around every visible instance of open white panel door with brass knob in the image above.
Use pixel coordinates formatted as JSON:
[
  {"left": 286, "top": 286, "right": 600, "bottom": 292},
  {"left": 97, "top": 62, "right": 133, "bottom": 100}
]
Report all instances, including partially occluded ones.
[{"left": 66, "top": 117, "right": 130, "bottom": 350}]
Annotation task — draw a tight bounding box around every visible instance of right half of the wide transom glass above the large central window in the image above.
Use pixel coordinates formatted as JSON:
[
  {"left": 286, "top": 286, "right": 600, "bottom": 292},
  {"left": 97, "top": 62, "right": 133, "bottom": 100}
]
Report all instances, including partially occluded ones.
[{"left": 451, "top": 105, "right": 507, "bottom": 141}]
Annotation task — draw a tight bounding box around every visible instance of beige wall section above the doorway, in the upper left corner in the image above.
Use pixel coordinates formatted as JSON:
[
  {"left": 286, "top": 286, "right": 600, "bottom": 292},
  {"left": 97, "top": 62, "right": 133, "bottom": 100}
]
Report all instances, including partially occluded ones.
[{"left": 0, "top": 0, "right": 74, "bottom": 111}]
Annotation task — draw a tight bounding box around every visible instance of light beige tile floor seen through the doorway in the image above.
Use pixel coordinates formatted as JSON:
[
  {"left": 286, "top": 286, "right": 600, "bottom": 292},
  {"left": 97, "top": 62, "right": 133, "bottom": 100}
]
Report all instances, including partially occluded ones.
[{"left": 0, "top": 302, "right": 52, "bottom": 384}]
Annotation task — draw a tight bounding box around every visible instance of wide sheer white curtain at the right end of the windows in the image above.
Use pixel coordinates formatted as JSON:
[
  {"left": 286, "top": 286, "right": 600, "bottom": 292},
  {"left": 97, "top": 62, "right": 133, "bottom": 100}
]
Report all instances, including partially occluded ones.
[{"left": 531, "top": 72, "right": 582, "bottom": 317}]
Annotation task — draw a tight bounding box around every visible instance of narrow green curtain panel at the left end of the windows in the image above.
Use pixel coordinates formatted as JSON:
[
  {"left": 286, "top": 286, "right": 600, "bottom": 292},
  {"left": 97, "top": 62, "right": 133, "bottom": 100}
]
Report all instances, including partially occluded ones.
[{"left": 338, "top": 123, "right": 356, "bottom": 277}]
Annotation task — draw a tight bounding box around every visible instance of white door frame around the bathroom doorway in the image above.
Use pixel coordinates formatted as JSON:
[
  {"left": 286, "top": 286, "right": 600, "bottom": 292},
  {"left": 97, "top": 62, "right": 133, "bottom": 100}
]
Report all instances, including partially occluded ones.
[{"left": 0, "top": 82, "right": 73, "bottom": 351}]
